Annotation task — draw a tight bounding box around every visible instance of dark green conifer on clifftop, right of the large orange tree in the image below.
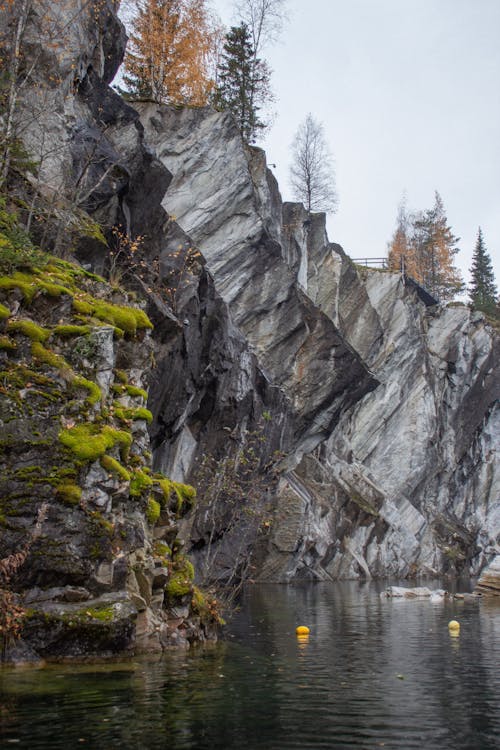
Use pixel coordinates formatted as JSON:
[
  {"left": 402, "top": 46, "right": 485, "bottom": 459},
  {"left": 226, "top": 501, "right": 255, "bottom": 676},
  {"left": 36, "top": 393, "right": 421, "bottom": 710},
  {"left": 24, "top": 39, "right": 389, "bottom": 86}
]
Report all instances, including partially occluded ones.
[{"left": 213, "top": 23, "right": 271, "bottom": 143}]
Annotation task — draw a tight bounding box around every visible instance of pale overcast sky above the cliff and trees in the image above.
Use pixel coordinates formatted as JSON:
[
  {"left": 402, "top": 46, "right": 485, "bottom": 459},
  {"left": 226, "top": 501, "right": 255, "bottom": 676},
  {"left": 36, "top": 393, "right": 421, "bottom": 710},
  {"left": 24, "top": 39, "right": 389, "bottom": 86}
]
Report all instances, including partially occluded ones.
[{"left": 213, "top": 0, "right": 500, "bottom": 286}]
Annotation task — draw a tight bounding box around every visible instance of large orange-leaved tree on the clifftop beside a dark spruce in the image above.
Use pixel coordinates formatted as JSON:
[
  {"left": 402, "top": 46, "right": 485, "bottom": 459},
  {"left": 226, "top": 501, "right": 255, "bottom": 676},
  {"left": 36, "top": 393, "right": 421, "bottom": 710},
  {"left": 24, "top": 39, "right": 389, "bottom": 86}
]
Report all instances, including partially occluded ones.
[{"left": 124, "top": 0, "right": 214, "bottom": 106}]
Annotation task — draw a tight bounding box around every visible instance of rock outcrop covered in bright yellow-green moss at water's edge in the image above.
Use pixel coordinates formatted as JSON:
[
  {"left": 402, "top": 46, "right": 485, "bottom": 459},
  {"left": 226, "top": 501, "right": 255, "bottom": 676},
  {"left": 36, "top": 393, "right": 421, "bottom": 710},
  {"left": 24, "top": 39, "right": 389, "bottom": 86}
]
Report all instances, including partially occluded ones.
[{"left": 0, "top": 178, "right": 216, "bottom": 657}]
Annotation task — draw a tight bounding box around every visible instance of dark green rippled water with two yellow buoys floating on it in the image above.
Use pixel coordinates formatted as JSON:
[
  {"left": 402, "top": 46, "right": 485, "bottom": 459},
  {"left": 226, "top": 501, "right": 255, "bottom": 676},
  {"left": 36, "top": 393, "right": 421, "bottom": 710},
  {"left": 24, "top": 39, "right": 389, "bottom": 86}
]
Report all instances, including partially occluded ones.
[{"left": 0, "top": 583, "right": 500, "bottom": 750}]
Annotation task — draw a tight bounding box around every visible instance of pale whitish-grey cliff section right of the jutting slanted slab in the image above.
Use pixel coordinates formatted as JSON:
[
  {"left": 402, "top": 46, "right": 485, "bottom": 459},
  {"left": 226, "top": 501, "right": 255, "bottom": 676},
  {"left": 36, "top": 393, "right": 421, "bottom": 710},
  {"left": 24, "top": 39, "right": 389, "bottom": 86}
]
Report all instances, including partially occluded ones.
[{"left": 272, "top": 212, "right": 500, "bottom": 578}]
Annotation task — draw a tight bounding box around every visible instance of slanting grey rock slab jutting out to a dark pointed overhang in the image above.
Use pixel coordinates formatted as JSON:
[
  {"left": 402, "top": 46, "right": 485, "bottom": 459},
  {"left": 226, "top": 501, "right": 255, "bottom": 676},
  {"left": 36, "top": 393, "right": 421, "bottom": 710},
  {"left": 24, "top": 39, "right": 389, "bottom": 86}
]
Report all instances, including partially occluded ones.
[{"left": 138, "top": 105, "right": 374, "bottom": 450}]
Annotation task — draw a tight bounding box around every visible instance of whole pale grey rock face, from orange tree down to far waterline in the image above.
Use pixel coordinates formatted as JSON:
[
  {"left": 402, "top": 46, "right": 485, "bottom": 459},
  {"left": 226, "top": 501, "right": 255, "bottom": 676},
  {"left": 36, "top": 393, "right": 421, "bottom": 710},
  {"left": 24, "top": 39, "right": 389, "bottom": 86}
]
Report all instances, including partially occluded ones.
[{"left": 136, "top": 105, "right": 500, "bottom": 580}]
